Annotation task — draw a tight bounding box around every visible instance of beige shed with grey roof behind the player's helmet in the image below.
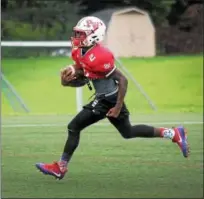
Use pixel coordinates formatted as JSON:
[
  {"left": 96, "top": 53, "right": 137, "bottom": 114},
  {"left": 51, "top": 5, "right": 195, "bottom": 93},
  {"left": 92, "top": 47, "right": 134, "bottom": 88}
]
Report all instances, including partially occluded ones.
[{"left": 92, "top": 7, "right": 156, "bottom": 57}]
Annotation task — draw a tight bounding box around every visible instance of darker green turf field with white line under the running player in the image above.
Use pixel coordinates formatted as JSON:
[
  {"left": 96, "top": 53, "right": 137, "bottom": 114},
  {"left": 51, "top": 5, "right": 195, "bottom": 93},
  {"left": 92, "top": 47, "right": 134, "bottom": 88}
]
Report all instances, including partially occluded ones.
[{"left": 2, "top": 114, "right": 203, "bottom": 198}]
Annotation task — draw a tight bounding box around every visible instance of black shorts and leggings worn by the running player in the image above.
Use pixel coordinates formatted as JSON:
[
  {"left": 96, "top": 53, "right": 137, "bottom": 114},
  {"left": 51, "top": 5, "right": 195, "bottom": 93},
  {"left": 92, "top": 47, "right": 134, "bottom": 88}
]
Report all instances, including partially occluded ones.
[{"left": 64, "top": 95, "right": 154, "bottom": 161}]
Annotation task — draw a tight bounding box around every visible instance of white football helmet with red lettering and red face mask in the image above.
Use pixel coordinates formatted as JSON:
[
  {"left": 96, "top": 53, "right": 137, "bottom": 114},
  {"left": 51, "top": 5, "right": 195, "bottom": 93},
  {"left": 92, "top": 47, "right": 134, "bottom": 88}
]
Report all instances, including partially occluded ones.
[{"left": 71, "top": 17, "right": 106, "bottom": 47}]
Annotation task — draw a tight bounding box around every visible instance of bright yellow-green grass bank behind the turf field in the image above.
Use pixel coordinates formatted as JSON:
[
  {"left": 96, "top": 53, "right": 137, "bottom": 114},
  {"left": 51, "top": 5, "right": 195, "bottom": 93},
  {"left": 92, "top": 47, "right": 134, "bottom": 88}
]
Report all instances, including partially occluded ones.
[{"left": 2, "top": 55, "right": 203, "bottom": 115}]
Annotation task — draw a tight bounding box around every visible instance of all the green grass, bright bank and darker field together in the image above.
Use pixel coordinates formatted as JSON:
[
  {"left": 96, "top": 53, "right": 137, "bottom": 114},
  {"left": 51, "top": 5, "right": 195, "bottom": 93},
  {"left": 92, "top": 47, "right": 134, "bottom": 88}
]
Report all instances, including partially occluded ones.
[{"left": 1, "top": 56, "right": 203, "bottom": 198}]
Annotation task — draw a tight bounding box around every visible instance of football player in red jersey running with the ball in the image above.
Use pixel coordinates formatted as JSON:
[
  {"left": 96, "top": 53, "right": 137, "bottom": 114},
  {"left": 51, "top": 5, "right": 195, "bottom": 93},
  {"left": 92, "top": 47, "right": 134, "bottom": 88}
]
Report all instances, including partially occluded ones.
[{"left": 36, "top": 16, "right": 189, "bottom": 179}]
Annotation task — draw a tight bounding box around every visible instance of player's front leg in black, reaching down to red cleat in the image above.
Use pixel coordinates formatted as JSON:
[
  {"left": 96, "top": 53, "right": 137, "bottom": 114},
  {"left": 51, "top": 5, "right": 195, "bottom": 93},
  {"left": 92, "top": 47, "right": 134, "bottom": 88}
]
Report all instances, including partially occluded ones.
[{"left": 36, "top": 101, "right": 105, "bottom": 179}]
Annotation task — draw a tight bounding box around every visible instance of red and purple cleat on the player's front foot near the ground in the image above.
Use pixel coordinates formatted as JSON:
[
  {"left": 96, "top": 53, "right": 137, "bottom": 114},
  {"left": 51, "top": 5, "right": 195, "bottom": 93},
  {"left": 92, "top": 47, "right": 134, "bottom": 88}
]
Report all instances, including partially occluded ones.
[{"left": 35, "top": 162, "right": 67, "bottom": 180}]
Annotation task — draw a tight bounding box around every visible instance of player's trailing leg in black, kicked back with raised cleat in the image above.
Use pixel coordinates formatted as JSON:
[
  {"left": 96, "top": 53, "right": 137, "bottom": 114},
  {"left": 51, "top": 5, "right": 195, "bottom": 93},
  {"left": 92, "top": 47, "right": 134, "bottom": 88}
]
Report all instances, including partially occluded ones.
[{"left": 108, "top": 105, "right": 189, "bottom": 157}]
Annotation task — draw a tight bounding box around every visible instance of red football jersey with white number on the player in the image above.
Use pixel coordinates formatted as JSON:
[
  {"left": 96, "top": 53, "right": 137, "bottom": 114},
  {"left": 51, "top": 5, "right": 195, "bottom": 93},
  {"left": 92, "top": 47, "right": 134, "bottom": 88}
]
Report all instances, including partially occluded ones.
[{"left": 72, "top": 44, "right": 116, "bottom": 80}]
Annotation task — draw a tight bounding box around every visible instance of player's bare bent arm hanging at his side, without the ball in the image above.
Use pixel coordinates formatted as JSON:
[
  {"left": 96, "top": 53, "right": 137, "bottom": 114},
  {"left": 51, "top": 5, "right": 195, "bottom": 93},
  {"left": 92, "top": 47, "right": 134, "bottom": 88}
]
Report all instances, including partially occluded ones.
[{"left": 111, "top": 69, "right": 128, "bottom": 110}]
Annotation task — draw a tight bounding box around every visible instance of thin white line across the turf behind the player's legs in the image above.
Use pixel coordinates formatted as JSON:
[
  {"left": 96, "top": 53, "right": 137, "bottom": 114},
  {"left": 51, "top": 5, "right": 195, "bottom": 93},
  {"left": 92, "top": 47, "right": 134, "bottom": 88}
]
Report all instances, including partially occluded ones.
[{"left": 1, "top": 121, "right": 203, "bottom": 128}]
